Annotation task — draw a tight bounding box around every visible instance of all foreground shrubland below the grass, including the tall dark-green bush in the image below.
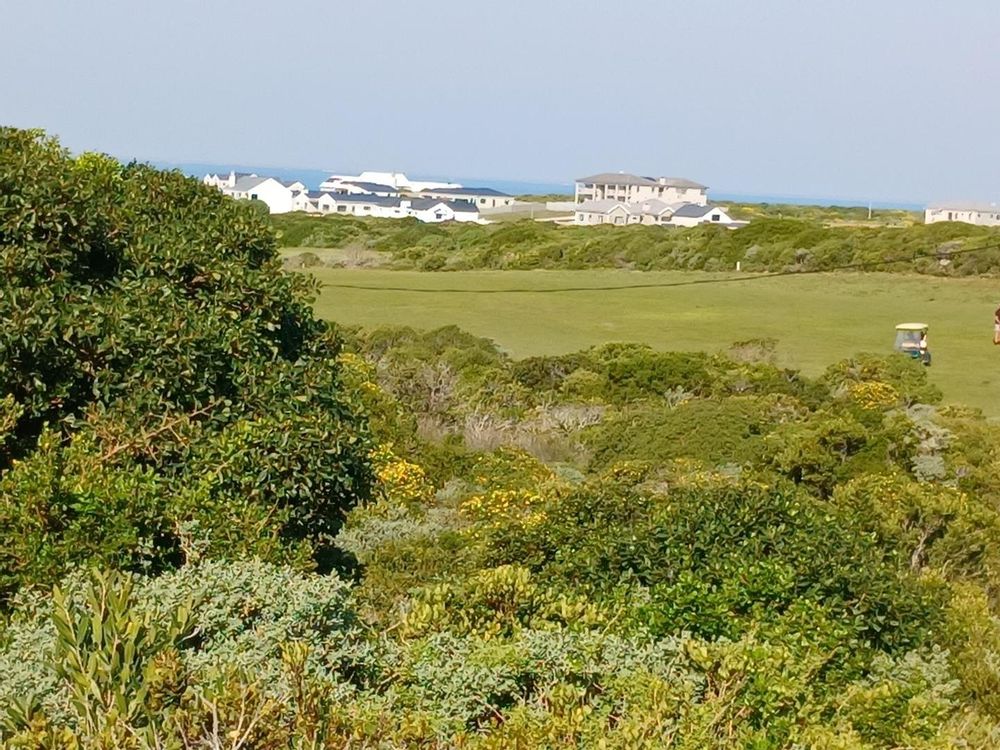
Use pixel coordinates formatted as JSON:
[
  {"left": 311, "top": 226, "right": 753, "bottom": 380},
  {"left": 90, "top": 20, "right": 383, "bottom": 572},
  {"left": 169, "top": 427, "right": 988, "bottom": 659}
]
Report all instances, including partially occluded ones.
[{"left": 0, "top": 129, "right": 1000, "bottom": 750}]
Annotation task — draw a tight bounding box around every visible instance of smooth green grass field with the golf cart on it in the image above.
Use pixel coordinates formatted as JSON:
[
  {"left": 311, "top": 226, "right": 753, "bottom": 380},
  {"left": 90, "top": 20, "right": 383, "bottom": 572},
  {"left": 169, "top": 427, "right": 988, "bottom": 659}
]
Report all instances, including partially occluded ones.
[{"left": 304, "top": 268, "right": 1000, "bottom": 417}]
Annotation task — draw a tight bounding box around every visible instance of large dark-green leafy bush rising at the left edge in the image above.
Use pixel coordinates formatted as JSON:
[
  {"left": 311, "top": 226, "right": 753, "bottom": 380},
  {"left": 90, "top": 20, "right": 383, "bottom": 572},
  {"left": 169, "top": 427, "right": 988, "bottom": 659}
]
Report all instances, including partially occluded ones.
[{"left": 0, "top": 128, "right": 369, "bottom": 598}]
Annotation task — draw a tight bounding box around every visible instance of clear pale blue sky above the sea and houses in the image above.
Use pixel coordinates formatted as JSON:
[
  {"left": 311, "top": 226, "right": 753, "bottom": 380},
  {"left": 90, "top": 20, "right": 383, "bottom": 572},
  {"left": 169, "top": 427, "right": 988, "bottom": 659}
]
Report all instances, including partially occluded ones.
[{"left": 0, "top": 0, "right": 1000, "bottom": 201}]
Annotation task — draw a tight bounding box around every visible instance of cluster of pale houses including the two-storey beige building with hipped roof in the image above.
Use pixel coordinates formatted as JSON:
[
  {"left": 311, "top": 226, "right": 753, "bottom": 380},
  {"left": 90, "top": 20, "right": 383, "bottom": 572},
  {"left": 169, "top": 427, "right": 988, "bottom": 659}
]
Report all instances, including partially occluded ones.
[{"left": 573, "top": 172, "right": 746, "bottom": 228}]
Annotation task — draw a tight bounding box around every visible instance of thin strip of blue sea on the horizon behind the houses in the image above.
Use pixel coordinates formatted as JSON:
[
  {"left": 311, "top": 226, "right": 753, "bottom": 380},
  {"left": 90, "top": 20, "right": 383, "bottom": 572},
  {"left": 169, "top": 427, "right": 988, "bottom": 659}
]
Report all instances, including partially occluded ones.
[{"left": 153, "top": 162, "right": 924, "bottom": 211}]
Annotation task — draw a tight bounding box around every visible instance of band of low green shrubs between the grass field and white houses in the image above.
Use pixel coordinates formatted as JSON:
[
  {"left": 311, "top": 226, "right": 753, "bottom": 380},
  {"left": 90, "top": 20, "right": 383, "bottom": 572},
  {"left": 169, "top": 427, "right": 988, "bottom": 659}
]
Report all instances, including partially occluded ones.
[{"left": 272, "top": 214, "right": 1000, "bottom": 276}]
